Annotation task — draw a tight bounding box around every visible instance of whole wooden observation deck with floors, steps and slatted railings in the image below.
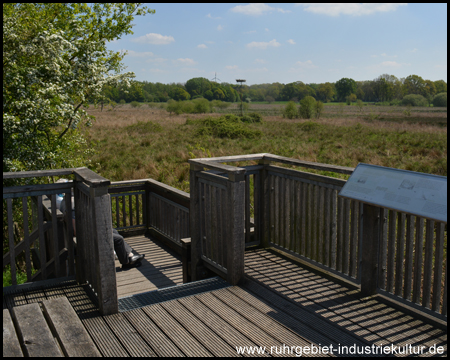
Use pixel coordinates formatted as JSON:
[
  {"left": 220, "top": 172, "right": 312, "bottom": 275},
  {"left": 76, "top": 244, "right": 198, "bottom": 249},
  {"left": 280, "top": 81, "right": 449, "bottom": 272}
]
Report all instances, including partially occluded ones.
[{"left": 3, "top": 154, "right": 447, "bottom": 356}]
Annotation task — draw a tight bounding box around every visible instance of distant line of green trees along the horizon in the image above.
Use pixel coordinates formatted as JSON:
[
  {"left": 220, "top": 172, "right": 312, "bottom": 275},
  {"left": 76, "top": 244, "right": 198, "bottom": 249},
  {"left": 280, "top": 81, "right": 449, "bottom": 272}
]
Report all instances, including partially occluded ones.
[{"left": 103, "top": 74, "right": 447, "bottom": 104}]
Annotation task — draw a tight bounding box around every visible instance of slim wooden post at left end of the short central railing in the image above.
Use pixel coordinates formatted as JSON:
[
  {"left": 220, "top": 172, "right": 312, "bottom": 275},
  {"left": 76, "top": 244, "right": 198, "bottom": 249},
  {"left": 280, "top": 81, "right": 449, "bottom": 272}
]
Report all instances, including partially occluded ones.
[{"left": 189, "top": 164, "right": 203, "bottom": 281}]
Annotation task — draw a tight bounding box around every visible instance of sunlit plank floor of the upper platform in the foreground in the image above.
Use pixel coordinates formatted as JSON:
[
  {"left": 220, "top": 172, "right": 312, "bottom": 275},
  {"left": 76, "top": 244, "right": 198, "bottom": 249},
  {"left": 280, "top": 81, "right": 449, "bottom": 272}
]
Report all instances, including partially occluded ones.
[{"left": 3, "top": 250, "right": 447, "bottom": 356}]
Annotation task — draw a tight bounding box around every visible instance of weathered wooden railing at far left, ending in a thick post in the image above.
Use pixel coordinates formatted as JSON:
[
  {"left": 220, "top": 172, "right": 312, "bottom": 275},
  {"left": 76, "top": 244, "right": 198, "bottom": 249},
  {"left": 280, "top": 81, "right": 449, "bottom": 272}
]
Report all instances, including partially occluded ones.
[{"left": 3, "top": 168, "right": 118, "bottom": 314}]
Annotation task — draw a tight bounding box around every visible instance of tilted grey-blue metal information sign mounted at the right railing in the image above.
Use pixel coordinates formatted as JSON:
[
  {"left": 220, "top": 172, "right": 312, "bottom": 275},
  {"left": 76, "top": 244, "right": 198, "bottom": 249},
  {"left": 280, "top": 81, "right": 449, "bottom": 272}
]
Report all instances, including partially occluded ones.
[{"left": 339, "top": 163, "right": 447, "bottom": 223}]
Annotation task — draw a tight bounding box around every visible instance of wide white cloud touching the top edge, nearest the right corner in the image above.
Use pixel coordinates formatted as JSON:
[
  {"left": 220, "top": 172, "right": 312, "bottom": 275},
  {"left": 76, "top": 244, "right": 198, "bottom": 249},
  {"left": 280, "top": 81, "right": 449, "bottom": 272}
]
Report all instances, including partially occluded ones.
[{"left": 297, "top": 3, "right": 407, "bottom": 16}]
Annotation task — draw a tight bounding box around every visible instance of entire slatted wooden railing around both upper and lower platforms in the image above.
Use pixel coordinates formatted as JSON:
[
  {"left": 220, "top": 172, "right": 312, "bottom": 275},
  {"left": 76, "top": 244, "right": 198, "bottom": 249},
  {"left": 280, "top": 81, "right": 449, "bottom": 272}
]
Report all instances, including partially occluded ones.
[{"left": 3, "top": 154, "right": 447, "bottom": 317}]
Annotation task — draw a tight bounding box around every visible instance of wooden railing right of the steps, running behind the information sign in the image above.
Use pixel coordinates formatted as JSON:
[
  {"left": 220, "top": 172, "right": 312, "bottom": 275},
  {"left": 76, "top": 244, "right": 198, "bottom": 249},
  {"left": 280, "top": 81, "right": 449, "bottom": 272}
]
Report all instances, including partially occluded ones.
[{"left": 189, "top": 154, "right": 447, "bottom": 316}]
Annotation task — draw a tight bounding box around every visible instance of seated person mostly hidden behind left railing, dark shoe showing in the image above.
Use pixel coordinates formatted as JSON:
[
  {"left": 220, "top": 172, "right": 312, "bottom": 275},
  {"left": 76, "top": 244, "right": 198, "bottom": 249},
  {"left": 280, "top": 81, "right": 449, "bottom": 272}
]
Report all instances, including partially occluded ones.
[{"left": 57, "top": 179, "right": 145, "bottom": 269}]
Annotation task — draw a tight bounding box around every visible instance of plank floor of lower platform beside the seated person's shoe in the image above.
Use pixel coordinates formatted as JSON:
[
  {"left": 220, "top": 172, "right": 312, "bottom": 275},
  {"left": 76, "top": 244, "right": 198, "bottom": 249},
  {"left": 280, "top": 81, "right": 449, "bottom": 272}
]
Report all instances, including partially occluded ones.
[{"left": 115, "top": 236, "right": 183, "bottom": 298}]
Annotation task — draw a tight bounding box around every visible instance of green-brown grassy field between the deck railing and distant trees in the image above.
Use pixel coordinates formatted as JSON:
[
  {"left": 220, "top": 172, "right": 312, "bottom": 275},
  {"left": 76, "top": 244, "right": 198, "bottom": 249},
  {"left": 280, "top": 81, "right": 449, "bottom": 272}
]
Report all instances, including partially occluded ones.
[{"left": 87, "top": 103, "right": 447, "bottom": 191}]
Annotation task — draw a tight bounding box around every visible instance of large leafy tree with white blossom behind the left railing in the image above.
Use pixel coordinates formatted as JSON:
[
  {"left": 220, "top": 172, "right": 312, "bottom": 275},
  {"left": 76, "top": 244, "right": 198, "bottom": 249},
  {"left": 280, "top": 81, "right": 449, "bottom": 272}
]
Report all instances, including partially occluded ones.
[{"left": 3, "top": 3, "right": 154, "bottom": 177}]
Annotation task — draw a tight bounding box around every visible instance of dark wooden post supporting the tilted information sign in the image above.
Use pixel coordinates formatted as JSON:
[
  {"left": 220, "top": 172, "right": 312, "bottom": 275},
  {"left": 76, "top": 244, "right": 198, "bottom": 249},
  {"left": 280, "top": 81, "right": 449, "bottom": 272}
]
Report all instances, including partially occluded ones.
[{"left": 361, "top": 204, "right": 381, "bottom": 296}]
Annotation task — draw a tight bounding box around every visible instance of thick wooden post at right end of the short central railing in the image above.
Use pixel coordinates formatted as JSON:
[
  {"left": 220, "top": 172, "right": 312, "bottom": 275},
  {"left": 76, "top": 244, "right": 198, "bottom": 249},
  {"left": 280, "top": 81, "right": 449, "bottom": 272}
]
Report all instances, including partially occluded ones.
[{"left": 226, "top": 173, "right": 245, "bottom": 285}]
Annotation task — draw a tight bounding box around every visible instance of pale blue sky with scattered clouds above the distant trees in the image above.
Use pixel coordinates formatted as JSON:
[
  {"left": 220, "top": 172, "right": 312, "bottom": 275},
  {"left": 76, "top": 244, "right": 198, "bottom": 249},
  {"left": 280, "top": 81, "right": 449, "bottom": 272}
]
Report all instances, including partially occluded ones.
[{"left": 108, "top": 3, "right": 447, "bottom": 85}]
